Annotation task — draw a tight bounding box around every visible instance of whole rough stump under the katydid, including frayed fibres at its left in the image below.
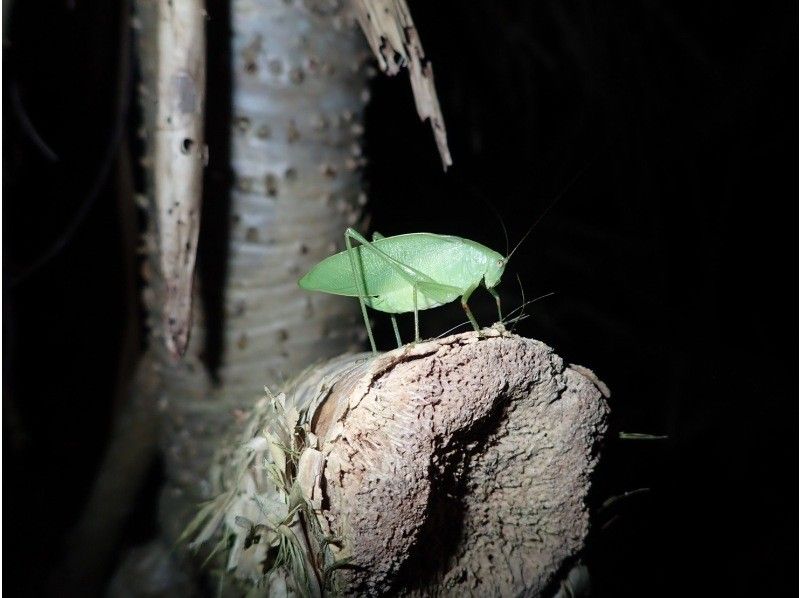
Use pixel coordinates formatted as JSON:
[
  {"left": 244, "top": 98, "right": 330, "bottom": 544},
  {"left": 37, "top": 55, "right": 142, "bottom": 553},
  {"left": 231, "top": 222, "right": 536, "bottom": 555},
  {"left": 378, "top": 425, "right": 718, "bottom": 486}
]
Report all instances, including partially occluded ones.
[{"left": 200, "top": 330, "right": 608, "bottom": 596}]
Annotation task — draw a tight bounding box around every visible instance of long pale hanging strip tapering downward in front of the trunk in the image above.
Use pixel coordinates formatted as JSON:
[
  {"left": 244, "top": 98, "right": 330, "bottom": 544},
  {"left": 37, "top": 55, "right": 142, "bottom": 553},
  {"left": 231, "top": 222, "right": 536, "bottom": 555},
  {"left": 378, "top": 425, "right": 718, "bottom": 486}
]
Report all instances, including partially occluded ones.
[{"left": 154, "top": 0, "right": 206, "bottom": 356}]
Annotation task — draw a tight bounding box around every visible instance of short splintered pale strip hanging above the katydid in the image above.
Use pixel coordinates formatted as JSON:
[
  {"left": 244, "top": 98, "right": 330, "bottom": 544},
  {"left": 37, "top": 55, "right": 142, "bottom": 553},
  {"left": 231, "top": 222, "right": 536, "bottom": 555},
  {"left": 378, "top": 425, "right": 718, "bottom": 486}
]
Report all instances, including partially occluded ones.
[{"left": 353, "top": 0, "right": 453, "bottom": 170}]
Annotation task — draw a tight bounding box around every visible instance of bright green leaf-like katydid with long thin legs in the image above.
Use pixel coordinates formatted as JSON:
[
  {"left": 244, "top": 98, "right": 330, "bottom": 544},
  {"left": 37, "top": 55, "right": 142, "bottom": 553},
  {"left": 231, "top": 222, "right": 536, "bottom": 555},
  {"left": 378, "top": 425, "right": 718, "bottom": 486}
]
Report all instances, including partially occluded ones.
[{"left": 299, "top": 228, "right": 513, "bottom": 352}]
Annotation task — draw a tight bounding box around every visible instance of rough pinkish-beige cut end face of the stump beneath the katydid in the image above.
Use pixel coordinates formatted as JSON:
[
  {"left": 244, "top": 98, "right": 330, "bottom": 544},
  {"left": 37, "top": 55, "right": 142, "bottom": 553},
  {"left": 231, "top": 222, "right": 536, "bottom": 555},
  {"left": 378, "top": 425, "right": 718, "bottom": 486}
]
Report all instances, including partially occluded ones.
[{"left": 306, "top": 331, "right": 607, "bottom": 595}]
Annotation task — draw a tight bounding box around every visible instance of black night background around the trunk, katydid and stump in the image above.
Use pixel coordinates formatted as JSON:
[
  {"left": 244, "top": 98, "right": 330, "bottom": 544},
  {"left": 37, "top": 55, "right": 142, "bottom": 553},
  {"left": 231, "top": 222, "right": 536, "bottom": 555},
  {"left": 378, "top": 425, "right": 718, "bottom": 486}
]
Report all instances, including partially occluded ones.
[{"left": 3, "top": 0, "right": 798, "bottom": 596}]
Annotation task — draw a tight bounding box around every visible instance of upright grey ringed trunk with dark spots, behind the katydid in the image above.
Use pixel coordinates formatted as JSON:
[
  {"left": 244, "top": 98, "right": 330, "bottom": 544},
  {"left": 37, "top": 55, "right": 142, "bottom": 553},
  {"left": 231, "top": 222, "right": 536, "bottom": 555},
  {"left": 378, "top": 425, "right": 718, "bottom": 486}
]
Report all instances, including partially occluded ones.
[{"left": 118, "top": 0, "right": 368, "bottom": 585}]
